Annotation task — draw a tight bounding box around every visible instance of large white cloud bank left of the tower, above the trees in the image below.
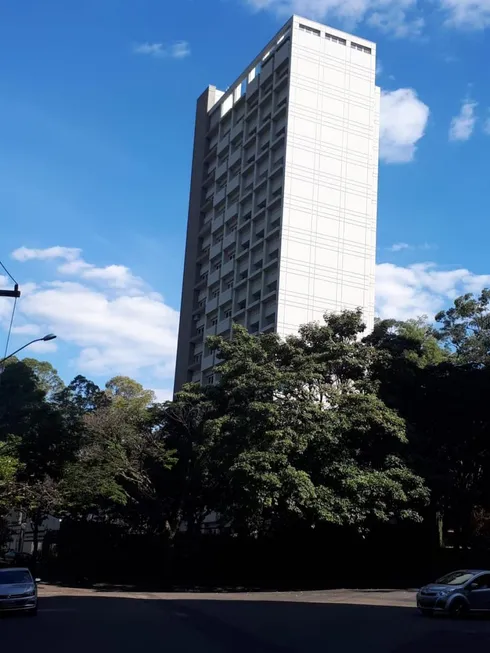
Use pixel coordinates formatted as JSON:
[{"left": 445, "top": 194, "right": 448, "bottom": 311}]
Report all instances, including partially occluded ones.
[{"left": 5, "top": 247, "right": 178, "bottom": 378}]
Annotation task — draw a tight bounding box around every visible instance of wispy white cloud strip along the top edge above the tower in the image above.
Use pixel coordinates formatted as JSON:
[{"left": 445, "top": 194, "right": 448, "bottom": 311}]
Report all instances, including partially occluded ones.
[{"left": 245, "top": 0, "right": 490, "bottom": 37}]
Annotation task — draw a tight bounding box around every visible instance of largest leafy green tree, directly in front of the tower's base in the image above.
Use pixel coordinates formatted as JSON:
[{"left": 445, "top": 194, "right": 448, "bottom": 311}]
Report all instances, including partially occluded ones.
[{"left": 193, "top": 311, "right": 428, "bottom": 533}]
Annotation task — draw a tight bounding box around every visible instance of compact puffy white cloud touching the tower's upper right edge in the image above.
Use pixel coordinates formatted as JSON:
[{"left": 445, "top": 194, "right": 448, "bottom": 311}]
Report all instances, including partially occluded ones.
[{"left": 380, "top": 88, "right": 430, "bottom": 163}]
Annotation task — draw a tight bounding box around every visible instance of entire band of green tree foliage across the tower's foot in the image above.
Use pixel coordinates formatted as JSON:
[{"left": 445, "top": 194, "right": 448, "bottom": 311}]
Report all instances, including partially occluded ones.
[{"left": 4, "top": 290, "right": 490, "bottom": 560}]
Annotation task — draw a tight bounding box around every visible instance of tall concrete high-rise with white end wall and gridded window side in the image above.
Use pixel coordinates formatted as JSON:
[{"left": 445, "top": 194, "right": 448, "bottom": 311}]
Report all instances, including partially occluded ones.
[{"left": 175, "top": 16, "right": 380, "bottom": 390}]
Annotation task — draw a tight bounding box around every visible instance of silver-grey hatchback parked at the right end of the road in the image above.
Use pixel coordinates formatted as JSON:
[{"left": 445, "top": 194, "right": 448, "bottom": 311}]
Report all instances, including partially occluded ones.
[{"left": 417, "top": 569, "right": 490, "bottom": 617}]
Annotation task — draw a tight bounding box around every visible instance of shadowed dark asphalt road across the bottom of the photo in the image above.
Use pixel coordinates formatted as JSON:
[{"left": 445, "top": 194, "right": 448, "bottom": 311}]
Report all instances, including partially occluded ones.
[{"left": 0, "top": 588, "right": 490, "bottom": 653}]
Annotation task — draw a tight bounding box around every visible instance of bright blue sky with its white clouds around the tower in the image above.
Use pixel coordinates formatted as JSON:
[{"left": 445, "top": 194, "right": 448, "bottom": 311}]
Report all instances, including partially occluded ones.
[{"left": 0, "top": 0, "right": 490, "bottom": 397}]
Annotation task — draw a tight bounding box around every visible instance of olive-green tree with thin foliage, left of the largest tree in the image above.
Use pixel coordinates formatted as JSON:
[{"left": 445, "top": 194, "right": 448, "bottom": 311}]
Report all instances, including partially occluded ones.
[{"left": 63, "top": 384, "right": 173, "bottom": 530}]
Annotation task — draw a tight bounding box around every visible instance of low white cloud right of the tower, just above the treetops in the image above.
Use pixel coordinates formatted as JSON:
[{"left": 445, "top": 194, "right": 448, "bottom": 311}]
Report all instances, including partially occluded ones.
[{"left": 376, "top": 263, "right": 490, "bottom": 320}]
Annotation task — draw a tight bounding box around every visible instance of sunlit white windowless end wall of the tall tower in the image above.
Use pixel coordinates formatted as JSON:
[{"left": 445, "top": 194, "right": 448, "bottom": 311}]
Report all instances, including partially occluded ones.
[{"left": 277, "top": 17, "right": 379, "bottom": 336}]
